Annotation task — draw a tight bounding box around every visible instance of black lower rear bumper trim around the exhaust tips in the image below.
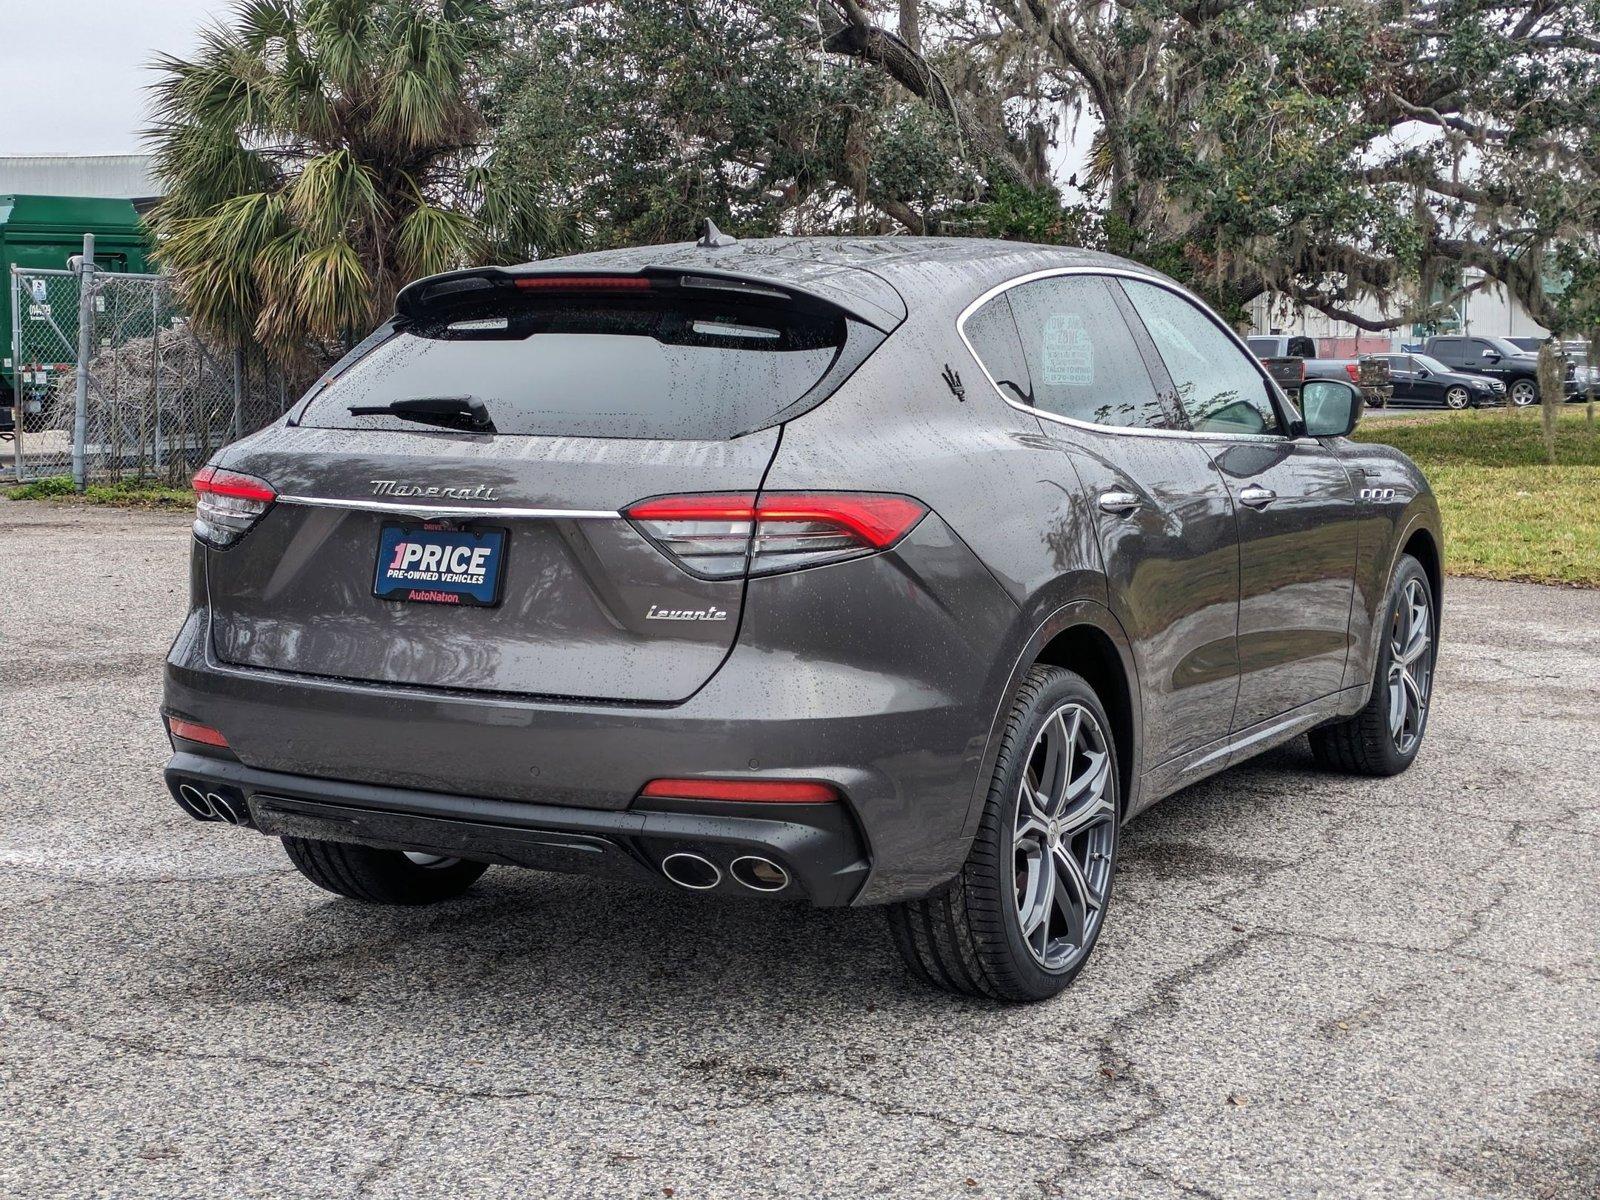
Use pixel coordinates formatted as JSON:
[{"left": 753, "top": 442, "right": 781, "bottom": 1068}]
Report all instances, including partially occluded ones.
[{"left": 165, "top": 750, "right": 867, "bottom": 906}]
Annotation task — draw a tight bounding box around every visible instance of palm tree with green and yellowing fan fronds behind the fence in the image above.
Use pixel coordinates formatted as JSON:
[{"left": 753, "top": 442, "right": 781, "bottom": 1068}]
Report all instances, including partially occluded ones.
[{"left": 147, "top": 0, "right": 573, "bottom": 360}]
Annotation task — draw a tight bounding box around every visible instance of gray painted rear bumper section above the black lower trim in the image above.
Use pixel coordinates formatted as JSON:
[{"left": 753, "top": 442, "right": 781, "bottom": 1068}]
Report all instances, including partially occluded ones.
[{"left": 165, "top": 514, "right": 1019, "bottom": 904}]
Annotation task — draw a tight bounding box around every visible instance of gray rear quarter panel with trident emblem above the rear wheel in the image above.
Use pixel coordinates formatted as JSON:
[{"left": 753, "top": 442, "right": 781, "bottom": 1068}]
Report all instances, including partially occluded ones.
[{"left": 765, "top": 275, "right": 1138, "bottom": 837}]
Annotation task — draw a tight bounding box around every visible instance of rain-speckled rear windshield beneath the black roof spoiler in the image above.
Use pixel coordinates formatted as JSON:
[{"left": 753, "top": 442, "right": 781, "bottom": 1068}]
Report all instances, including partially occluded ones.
[{"left": 299, "top": 294, "right": 850, "bottom": 440}]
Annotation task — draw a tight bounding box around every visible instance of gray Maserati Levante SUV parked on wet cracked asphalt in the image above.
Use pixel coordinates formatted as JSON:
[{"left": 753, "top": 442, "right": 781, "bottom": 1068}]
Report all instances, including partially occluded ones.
[{"left": 163, "top": 229, "right": 1440, "bottom": 1000}]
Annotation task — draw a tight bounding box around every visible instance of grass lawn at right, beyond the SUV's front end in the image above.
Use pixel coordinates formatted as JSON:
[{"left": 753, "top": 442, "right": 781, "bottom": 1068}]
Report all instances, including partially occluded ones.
[{"left": 1355, "top": 405, "right": 1600, "bottom": 587}]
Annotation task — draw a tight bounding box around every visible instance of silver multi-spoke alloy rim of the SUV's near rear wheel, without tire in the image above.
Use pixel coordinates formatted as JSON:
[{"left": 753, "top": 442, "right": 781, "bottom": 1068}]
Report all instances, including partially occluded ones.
[{"left": 1013, "top": 702, "right": 1117, "bottom": 971}]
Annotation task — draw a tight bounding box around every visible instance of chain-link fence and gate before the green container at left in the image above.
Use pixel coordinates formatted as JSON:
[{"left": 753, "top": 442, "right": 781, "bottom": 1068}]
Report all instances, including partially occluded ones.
[{"left": 0, "top": 246, "right": 290, "bottom": 486}]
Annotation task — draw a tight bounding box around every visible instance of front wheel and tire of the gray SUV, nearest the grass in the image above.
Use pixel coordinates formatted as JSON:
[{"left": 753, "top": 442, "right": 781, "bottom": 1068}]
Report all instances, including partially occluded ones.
[{"left": 1310, "top": 554, "right": 1438, "bottom": 776}]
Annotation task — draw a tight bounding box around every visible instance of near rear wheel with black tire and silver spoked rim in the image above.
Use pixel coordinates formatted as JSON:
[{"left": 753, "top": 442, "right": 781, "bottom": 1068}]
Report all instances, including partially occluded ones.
[{"left": 888, "top": 666, "right": 1122, "bottom": 1002}]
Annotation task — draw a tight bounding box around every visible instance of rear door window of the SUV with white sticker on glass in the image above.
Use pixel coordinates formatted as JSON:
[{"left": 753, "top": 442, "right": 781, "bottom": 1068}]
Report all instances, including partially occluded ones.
[{"left": 1006, "top": 275, "right": 1170, "bottom": 429}]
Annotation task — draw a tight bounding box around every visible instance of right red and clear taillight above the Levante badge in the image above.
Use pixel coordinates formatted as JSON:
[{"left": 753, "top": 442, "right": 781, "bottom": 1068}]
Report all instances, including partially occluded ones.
[{"left": 624, "top": 491, "right": 928, "bottom": 579}]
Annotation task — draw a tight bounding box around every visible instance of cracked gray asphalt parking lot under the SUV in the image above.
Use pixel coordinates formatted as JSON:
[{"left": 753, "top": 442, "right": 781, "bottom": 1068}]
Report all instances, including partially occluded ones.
[{"left": 0, "top": 501, "right": 1600, "bottom": 1200}]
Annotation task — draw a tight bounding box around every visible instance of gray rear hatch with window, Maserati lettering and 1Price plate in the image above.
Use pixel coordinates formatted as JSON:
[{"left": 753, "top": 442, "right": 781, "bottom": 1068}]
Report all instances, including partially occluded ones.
[{"left": 205, "top": 270, "right": 885, "bottom": 702}]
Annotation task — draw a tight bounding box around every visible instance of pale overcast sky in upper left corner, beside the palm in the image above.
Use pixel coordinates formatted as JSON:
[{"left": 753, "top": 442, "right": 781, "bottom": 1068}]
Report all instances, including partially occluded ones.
[{"left": 0, "top": 0, "right": 232, "bottom": 155}]
